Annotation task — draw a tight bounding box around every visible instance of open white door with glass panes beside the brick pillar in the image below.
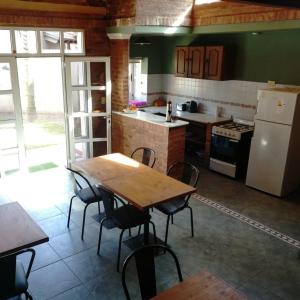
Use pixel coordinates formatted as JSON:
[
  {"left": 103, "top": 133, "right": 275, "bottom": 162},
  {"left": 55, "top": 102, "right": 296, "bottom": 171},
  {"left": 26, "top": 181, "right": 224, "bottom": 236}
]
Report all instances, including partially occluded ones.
[{"left": 65, "top": 57, "right": 111, "bottom": 163}]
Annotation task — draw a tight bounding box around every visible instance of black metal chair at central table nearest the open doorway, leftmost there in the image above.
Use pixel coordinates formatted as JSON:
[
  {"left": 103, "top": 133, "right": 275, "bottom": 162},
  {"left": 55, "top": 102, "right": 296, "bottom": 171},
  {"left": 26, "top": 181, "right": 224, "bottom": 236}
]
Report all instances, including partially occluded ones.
[{"left": 66, "top": 167, "right": 102, "bottom": 240}]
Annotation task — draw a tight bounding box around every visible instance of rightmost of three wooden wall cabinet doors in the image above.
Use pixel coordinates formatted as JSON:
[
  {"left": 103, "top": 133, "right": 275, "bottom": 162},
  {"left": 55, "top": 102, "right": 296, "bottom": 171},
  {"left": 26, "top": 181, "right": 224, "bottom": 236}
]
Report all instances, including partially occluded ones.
[{"left": 204, "top": 46, "right": 224, "bottom": 80}]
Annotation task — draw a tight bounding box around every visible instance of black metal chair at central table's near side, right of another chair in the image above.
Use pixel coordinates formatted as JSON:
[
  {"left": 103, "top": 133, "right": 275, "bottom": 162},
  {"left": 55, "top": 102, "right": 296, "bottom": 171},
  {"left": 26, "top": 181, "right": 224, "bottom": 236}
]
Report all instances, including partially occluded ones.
[{"left": 97, "top": 187, "right": 156, "bottom": 272}]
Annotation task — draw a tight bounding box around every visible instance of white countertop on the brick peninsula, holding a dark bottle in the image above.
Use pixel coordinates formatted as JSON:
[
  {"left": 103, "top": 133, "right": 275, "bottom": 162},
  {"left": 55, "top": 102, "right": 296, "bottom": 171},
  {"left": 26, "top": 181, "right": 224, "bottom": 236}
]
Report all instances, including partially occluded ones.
[{"left": 113, "top": 111, "right": 189, "bottom": 128}]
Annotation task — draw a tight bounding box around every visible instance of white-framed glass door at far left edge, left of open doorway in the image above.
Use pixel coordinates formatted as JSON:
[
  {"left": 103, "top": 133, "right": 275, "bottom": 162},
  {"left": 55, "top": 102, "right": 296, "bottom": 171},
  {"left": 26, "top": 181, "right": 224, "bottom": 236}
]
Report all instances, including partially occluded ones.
[{"left": 0, "top": 57, "right": 25, "bottom": 177}]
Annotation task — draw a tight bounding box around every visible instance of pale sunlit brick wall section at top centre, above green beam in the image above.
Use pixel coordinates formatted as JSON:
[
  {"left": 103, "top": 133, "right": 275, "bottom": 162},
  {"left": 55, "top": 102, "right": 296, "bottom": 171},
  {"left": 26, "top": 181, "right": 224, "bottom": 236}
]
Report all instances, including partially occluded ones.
[{"left": 135, "top": 0, "right": 194, "bottom": 26}]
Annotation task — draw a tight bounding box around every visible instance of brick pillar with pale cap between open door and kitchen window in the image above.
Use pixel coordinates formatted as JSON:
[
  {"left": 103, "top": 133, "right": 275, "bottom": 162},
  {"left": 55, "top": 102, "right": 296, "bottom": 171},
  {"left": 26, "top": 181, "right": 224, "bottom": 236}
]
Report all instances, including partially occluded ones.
[{"left": 108, "top": 34, "right": 130, "bottom": 111}]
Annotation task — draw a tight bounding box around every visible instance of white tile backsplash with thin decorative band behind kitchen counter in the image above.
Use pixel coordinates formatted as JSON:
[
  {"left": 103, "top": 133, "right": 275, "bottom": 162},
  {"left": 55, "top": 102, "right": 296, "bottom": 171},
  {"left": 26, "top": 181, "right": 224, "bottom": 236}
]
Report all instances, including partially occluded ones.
[{"left": 147, "top": 74, "right": 298, "bottom": 120}]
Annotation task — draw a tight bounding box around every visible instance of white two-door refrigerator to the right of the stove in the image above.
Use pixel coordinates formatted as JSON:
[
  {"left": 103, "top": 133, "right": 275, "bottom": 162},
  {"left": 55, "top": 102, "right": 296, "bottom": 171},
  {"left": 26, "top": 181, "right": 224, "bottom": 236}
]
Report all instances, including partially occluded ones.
[{"left": 246, "top": 88, "right": 300, "bottom": 197}]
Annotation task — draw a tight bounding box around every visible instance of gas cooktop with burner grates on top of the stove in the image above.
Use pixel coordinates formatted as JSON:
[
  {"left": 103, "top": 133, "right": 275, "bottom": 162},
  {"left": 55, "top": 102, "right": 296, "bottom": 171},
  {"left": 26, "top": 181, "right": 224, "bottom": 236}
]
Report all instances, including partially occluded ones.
[{"left": 212, "top": 119, "right": 254, "bottom": 140}]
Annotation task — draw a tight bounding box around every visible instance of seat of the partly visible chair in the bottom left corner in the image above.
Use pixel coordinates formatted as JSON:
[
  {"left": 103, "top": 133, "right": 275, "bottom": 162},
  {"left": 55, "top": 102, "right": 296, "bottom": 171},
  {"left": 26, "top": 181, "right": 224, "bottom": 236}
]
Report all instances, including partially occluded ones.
[{"left": 0, "top": 260, "right": 28, "bottom": 299}]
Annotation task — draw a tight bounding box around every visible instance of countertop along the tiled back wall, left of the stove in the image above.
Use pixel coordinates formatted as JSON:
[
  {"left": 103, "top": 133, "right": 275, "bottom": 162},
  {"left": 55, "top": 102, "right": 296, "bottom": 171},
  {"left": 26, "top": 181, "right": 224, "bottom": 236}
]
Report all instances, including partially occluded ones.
[{"left": 143, "top": 106, "right": 230, "bottom": 124}]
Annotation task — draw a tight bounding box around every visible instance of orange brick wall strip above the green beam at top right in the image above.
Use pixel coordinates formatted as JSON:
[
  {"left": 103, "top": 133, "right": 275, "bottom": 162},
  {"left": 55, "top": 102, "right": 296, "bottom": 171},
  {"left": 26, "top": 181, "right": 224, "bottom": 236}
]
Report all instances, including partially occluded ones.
[{"left": 193, "top": 2, "right": 300, "bottom": 26}]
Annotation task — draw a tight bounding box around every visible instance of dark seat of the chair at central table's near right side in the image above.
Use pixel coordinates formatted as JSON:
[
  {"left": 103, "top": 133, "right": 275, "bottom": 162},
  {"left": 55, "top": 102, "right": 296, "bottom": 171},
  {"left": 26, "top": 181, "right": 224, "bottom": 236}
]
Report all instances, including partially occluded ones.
[{"left": 111, "top": 205, "right": 151, "bottom": 229}]
